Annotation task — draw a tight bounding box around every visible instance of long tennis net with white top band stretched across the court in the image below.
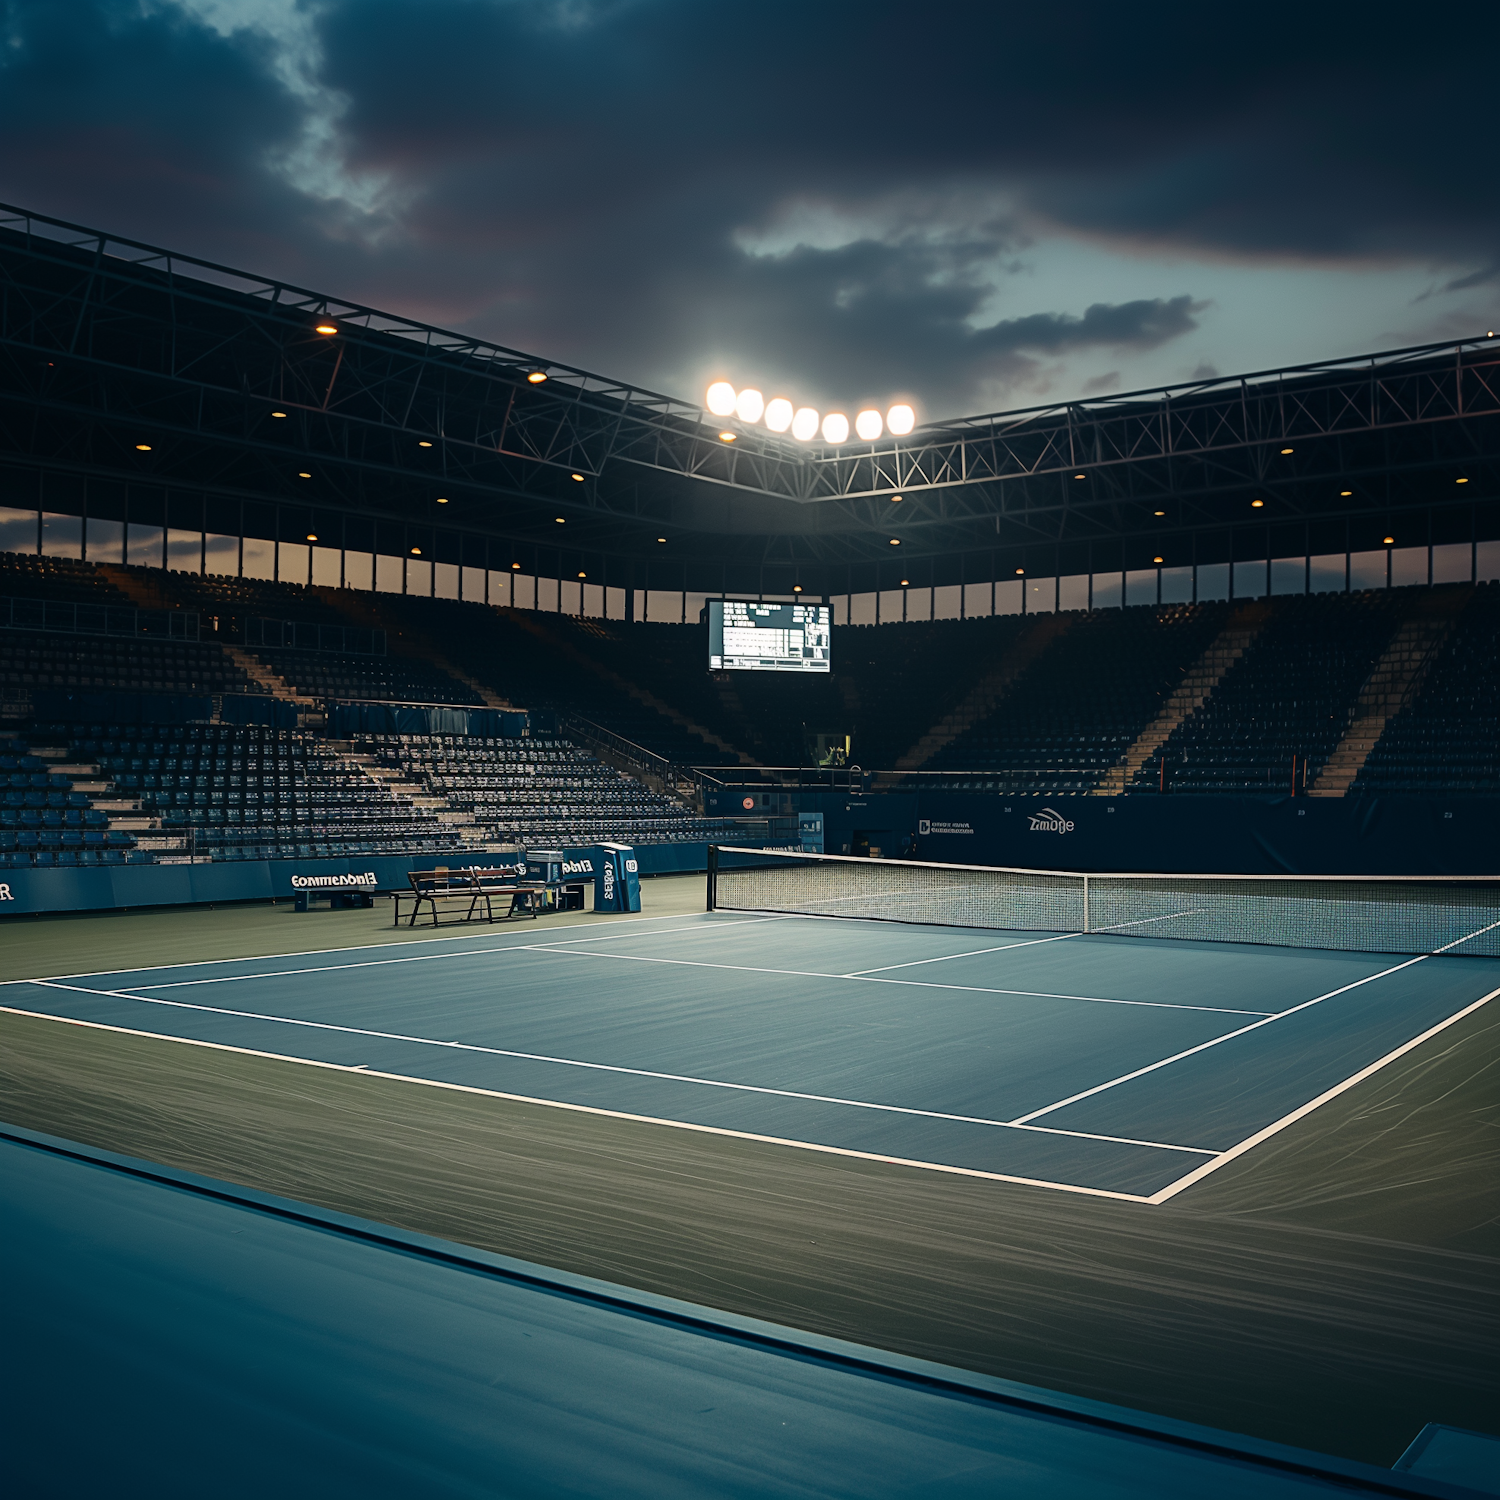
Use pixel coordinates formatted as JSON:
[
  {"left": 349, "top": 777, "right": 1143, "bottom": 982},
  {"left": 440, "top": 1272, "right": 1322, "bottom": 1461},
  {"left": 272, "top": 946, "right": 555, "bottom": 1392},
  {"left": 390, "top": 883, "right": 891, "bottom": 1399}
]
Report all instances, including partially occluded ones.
[{"left": 708, "top": 846, "right": 1500, "bottom": 956}]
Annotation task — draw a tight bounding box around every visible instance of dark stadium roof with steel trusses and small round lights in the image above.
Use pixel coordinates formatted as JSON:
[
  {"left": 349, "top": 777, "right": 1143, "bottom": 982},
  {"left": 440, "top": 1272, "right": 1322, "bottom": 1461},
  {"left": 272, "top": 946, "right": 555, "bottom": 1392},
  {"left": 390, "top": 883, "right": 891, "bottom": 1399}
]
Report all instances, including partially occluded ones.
[{"left": 0, "top": 206, "right": 1500, "bottom": 593}]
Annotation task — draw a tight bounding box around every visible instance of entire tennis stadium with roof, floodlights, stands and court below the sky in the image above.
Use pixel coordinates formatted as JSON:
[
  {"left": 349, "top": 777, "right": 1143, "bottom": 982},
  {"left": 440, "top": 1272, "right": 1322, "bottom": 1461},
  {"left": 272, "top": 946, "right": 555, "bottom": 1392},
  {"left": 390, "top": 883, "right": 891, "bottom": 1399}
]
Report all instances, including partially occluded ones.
[{"left": 0, "top": 196, "right": 1500, "bottom": 1497}]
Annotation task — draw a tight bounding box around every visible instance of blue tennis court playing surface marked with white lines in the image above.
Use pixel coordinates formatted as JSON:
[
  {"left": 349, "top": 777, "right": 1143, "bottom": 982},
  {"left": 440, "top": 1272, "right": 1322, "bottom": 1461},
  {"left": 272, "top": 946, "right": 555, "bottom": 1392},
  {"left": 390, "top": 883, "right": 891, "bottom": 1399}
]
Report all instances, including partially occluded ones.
[{"left": 0, "top": 912, "right": 1500, "bottom": 1203}]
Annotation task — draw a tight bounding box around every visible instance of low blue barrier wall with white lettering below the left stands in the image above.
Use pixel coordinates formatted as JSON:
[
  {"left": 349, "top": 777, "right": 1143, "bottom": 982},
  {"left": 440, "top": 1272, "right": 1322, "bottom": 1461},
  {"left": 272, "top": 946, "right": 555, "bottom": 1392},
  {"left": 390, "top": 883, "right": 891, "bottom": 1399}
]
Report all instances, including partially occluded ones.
[{"left": 0, "top": 843, "right": 708, "bottom": 917}]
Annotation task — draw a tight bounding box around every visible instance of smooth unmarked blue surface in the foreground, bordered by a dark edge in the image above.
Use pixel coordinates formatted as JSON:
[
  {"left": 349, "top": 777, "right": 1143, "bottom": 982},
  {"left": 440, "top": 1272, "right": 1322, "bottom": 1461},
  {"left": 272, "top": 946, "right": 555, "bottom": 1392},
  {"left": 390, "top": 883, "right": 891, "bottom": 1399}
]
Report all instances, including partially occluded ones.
[{"left": 0, "top": 1130, "right": 1469, "bottom": 1500}]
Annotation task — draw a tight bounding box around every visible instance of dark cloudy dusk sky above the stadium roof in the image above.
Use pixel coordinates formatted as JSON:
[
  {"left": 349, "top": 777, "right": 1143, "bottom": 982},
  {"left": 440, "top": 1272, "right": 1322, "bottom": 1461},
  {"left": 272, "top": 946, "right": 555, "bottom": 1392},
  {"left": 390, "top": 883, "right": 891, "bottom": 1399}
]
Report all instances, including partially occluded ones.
[{"left": 0, "top": 0, "right": 1500, "bottom": 420}]
